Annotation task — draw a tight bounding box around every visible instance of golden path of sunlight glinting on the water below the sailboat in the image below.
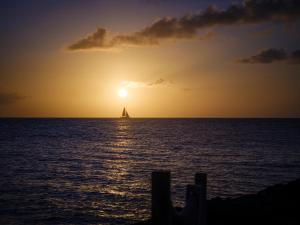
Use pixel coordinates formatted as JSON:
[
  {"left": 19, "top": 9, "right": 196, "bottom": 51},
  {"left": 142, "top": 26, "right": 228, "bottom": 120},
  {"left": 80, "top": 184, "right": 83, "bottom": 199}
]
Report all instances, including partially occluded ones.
[{"left": 98, "top": 120, "right": 150, "bottom": 220}]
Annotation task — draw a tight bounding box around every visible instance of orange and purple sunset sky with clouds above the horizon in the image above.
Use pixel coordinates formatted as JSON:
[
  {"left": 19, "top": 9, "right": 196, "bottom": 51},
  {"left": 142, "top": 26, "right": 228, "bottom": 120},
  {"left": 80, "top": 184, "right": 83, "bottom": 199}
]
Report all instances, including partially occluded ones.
[{"left": 0, "top": 0, "right": 300, "bottom": 117}]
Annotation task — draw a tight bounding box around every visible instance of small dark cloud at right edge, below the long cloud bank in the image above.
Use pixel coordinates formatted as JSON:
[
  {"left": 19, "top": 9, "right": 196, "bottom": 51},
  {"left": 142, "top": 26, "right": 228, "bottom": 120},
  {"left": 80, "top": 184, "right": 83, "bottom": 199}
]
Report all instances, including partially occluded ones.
[{"left": 238, "top": 48, "right": 300, "bottom": 64}]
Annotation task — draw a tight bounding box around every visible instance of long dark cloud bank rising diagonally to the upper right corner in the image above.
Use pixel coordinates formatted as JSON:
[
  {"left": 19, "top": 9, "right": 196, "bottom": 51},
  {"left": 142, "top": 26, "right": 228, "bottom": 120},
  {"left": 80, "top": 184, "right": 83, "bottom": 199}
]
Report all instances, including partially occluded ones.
[{"left": 68, "top": 0, "right": 300, "bottom": 50}]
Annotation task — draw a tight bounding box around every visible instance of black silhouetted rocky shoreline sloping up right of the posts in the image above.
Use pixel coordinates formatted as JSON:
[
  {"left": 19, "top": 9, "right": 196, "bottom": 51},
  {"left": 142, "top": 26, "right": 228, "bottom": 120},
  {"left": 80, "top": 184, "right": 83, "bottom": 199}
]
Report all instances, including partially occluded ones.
[{"left": 135, "top": 178, "right": 300, "bottom": 225}]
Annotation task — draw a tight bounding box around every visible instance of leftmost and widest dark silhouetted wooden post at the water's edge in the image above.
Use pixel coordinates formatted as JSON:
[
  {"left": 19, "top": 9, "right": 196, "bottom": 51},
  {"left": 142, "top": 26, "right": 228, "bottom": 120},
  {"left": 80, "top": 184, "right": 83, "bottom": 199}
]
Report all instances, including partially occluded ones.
[{"left": 152, "top": 171, "right": 172, "bottom": 225}]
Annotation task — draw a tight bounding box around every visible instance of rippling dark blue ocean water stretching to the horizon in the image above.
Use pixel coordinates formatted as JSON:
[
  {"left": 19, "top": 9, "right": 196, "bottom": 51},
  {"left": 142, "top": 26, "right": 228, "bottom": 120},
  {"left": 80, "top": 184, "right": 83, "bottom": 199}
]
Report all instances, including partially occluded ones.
[{"left": 0, "top": 119, "right": 300, "bottom": 224}]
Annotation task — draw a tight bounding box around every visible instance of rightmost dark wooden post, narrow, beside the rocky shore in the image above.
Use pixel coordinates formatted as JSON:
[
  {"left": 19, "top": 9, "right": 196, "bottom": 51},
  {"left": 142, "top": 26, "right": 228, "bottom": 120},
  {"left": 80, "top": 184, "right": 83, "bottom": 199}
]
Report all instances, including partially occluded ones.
[{"left": 195, "top": 173, "right": 207, "bottom": 225}]
